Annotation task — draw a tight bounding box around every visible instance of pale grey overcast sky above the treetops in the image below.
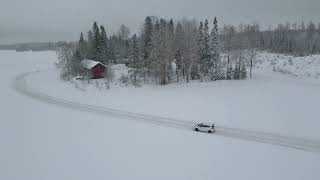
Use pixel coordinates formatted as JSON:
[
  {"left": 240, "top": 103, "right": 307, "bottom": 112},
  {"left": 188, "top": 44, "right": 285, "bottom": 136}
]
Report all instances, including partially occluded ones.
[{"left": 0, "top": 0, "right": 320, "bottom": 44}]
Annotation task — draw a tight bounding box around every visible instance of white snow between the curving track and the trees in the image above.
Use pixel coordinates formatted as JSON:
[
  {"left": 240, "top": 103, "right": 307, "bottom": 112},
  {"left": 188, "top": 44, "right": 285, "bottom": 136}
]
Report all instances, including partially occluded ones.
[{"left": 27, "top": 53, "right": 320, "bottom": 138}]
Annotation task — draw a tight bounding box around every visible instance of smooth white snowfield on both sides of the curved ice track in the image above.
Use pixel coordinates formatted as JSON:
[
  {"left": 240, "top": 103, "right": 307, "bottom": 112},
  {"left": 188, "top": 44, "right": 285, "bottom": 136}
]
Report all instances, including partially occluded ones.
[{"left": 0, "top": 51, "right": 320, "bottom": 180}]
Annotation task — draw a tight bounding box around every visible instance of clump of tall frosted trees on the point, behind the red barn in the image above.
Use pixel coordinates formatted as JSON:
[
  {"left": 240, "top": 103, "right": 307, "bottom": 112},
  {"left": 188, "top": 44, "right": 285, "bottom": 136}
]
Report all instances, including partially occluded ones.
[{"left": 57, "top": 16, "right": 246, "bottom": 85}]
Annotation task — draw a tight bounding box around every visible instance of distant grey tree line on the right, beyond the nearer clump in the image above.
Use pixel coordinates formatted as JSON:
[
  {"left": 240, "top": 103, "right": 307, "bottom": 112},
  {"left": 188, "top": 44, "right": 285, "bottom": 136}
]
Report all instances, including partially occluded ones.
[{"left": 221, "top": 21, "right": 320, "bottom": 56}]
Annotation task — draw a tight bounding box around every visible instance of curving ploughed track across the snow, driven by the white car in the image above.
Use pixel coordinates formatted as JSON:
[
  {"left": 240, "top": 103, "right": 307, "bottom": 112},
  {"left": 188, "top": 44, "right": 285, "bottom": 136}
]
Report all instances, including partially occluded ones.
[{"left": 13, "top": 71, "right": 320, "bottom": 153}]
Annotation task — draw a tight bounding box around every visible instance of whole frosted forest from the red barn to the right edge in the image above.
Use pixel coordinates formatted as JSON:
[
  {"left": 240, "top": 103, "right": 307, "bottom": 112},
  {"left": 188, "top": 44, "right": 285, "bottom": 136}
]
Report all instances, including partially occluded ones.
[{"left": 57, "top": 16, "right": 320, "bottom": 85}]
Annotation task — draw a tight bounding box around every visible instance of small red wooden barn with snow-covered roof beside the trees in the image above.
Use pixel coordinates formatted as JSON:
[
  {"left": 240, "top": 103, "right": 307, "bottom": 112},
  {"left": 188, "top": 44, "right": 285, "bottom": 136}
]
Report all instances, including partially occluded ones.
[{"left": 81, "top": 59, "right": 108, "bottom": 79}]
